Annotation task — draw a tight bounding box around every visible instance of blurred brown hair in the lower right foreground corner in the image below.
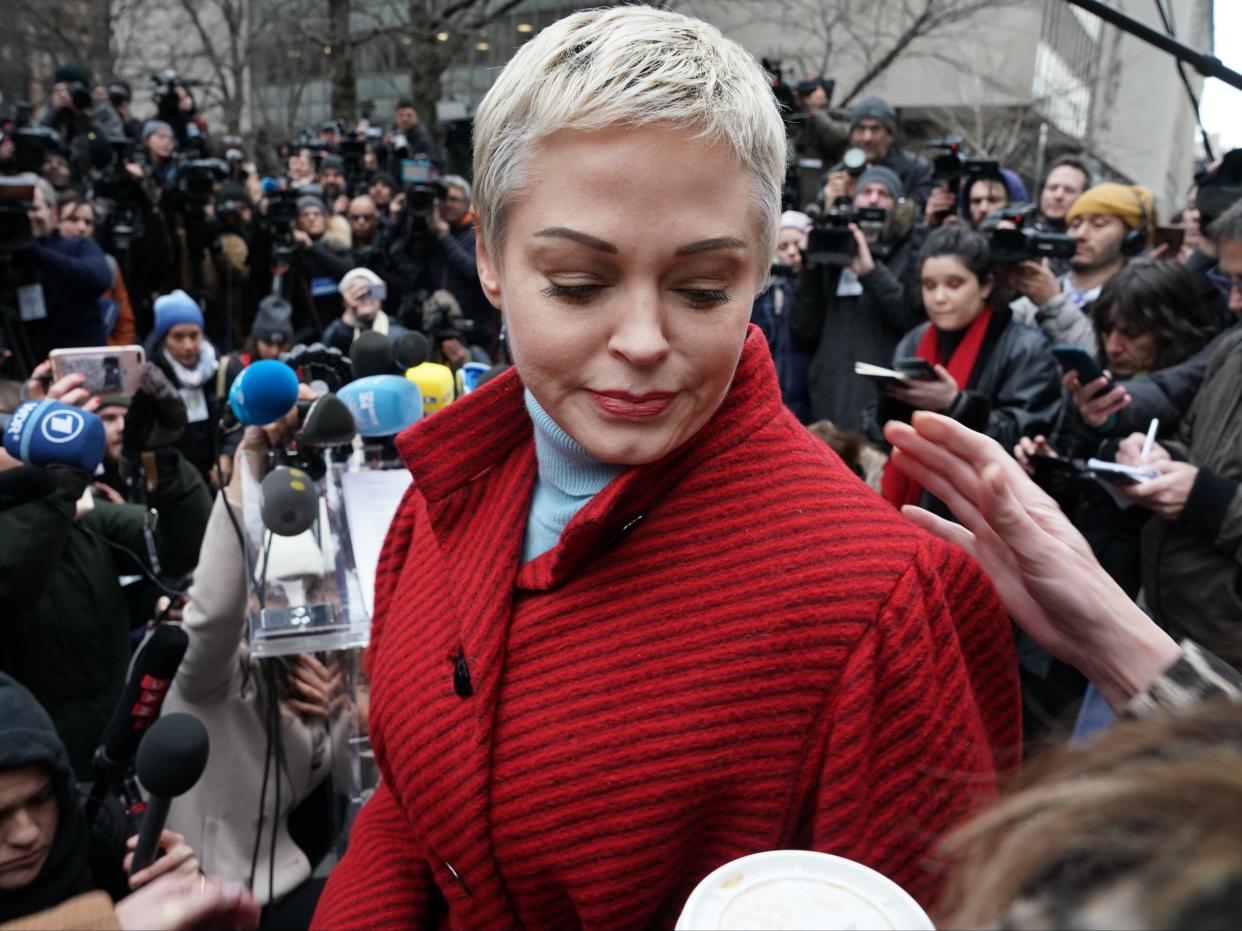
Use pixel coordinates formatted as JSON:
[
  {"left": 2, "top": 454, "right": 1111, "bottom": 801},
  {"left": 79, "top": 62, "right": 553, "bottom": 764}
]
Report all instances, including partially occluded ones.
[{"left": 938, "top": 700, "right": 1242, "bottom": 927}]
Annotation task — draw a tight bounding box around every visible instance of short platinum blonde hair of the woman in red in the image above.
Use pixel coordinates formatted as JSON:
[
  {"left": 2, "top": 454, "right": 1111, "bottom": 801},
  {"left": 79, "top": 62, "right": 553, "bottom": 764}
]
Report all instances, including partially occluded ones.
[{"left": 474, "top": 6, "right": 785, "bottom": 264}]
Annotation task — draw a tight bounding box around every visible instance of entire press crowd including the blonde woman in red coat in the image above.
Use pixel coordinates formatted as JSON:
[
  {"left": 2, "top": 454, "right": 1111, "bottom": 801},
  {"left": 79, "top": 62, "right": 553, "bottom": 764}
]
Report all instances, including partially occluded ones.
[{"left": 0, "top": 7, "right": 1242, "bottom": 929}]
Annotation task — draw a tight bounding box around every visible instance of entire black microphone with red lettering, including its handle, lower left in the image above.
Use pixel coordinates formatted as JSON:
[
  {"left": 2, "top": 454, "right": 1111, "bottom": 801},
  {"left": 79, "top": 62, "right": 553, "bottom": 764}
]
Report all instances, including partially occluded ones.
[{"left": 86, "top": 624, "right": 190, "bottom": 819}]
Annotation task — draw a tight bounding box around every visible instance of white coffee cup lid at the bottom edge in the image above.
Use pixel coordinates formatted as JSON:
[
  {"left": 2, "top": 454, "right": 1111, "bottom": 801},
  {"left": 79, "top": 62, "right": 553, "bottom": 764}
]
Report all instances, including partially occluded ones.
[{"left": 677, "top": 850, "right": 935, "bottom": 931}]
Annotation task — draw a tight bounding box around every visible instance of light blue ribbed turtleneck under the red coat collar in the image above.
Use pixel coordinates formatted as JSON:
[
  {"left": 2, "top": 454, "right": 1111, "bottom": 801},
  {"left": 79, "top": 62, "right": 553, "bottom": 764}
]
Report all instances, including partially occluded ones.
[{"left": 522, "top": 391, "right": 625, "bottom": 564}]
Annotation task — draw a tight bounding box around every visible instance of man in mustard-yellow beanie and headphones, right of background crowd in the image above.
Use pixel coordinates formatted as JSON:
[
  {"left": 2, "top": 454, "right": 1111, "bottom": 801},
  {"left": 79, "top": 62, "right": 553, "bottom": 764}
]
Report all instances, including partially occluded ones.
[{"left": 1007, "top": 182, "right": 1155, "bottom": 354}]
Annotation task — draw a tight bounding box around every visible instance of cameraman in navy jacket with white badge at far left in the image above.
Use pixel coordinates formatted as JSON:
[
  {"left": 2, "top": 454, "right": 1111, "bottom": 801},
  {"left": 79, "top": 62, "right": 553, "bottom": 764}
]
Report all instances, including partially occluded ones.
[{"left": 15, "top": 175, "right": 112, "bottom": 360}]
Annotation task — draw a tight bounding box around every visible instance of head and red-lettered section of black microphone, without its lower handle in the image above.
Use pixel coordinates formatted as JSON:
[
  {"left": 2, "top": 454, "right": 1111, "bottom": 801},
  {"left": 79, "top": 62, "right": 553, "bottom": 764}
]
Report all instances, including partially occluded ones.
[{"left": 95, "top": 624, "right": 190, "bottom": 766}]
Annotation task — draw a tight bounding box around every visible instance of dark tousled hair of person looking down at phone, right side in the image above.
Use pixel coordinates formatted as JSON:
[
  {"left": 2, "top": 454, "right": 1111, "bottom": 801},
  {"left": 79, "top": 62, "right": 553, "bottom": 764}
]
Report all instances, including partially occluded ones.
[{"left": 1084, "top": 258, "right": 1212, "bottom": 369}]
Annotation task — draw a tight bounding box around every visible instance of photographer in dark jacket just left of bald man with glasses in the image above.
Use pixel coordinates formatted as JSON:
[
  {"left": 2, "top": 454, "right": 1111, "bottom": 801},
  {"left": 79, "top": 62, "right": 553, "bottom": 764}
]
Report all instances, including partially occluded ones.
[{"left": 288, "top": 194, "right": 354, "bottom": 335}]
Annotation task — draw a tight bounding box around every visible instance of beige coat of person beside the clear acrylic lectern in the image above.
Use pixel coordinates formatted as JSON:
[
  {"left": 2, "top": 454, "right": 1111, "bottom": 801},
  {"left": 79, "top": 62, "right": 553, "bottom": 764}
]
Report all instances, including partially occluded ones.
[{"left": 164, "top": 495, "right": 332, "bottom": 905}]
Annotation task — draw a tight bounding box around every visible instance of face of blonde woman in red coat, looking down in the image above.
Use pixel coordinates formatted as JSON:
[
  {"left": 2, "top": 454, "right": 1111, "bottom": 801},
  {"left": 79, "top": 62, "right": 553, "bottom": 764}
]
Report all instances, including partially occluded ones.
[{"left": 478, "top": 127, "right": 770, "bottom": 466}]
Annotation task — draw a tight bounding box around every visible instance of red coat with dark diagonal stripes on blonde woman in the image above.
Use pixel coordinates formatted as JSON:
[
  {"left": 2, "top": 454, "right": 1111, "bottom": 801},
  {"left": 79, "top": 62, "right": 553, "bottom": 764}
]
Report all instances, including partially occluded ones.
[{"left": 314, "top": 328, "right": 1020, "bottom": 929}]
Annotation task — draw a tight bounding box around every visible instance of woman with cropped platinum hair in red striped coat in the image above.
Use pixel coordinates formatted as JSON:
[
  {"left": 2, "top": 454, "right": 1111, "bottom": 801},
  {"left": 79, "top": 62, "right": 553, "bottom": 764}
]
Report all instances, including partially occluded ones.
[{"left": 315, "top": 6, "right": 1020, "bottom": 929}]
